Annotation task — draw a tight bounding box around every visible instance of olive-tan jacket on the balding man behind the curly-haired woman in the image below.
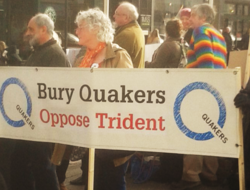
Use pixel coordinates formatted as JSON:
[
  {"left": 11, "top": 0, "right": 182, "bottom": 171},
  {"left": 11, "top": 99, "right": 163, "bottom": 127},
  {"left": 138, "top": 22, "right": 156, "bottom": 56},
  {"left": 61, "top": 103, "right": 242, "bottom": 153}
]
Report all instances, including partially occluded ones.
[{"left": 114, "top": 21, "right": 145, "bottom": 68}]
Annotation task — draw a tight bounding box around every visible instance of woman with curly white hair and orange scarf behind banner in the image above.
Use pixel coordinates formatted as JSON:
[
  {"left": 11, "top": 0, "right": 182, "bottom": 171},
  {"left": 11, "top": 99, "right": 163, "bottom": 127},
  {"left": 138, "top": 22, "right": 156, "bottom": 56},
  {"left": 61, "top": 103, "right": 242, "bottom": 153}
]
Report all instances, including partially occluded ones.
[{"left": 67, "top": 8, "right": 133, "bottom": 190}]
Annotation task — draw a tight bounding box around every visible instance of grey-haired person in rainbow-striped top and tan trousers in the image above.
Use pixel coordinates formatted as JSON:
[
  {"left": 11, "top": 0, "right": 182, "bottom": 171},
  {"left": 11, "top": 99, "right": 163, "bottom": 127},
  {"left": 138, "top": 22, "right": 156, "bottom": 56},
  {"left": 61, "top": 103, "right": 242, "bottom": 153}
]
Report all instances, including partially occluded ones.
[{"left": 172, "top": 4, "right": 227, "bottom": 190}]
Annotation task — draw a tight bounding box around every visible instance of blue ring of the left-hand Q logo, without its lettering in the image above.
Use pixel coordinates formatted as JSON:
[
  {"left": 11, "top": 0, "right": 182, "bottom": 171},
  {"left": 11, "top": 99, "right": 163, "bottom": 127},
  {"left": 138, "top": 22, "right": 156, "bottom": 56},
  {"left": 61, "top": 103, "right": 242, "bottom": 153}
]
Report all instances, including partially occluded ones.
[{"left": 0, "top": 78, "right": 32, "bottom": 127}]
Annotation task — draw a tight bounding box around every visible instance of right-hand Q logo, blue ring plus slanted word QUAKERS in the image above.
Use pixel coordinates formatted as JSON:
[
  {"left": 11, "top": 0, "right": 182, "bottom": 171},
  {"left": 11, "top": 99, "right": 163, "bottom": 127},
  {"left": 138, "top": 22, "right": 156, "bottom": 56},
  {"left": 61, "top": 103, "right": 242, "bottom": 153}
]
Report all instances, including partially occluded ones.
[{"left": 174, "top": 82, "right": 228, "bottom": 143}]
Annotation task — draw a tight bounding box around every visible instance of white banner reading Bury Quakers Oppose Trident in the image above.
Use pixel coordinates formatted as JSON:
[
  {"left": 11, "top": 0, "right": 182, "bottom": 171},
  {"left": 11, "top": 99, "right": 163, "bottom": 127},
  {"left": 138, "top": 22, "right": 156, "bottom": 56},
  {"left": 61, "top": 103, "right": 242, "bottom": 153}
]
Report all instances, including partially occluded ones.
[{"left": 0, "top": 67, "right": 240, "bottom": 158}]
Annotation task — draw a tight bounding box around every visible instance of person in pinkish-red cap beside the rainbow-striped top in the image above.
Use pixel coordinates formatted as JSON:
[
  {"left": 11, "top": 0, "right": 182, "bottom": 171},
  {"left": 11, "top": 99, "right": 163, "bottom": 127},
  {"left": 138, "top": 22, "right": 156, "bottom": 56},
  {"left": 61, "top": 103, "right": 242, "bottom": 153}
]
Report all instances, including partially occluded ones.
[{"left": 180, "top": 8, "right": 193, "bottom": 43}]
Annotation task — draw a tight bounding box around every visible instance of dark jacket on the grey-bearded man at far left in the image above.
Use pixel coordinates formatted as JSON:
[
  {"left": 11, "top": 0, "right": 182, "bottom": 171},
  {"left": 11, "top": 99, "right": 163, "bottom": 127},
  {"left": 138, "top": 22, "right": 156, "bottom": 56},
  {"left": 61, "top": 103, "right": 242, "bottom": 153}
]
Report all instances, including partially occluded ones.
[{"left": 25, "top": 38, "right": 70, "bottom": 67}]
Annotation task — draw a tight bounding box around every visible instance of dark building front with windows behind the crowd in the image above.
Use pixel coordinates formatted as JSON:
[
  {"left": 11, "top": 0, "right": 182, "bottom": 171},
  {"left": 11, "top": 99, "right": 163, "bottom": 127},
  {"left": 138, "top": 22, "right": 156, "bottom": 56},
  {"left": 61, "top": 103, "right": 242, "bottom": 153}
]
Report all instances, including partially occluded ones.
[{"left": 0, "top": 0, "right": 250, "bottom": 49}]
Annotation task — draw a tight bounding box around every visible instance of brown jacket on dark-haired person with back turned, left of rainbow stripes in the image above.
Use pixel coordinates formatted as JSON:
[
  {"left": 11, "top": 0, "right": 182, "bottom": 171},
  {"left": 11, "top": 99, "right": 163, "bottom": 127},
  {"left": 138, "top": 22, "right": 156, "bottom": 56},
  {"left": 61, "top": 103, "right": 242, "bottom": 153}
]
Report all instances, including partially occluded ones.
[{"left": 145, "top": 37, "right": 181, "bottom": 68}]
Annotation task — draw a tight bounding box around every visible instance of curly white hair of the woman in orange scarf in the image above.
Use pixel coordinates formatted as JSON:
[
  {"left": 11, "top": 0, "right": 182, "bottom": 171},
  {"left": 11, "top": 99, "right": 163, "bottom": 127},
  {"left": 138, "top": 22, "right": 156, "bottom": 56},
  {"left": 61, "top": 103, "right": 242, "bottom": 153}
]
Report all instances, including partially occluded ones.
[{"left": 75, "top": 8, "right": 115, "bottom": 43}]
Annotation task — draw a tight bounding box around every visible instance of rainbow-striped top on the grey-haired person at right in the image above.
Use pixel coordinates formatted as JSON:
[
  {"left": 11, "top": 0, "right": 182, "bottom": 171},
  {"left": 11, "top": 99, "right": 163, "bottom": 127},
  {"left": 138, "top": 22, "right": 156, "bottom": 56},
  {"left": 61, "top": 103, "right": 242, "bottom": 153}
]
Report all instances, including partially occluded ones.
[{"left": 186, "top": 24, "right": 227, "bottom": 69}]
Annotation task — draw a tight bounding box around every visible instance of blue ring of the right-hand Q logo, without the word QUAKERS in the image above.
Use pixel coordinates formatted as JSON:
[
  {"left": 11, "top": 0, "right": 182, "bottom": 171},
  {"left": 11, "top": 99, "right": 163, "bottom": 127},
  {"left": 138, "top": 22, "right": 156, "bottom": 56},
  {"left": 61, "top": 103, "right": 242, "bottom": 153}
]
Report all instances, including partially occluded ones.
[{"left": 174, "top": 82, "right": 226, "bottom": 141}]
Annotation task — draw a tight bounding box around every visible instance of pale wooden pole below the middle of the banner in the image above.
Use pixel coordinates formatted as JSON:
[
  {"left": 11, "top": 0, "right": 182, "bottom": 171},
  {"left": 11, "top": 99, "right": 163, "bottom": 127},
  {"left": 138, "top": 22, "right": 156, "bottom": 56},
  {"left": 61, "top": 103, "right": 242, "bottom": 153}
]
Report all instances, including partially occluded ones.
[{"left": 88, "top": 148, "right": 95, "bottom": 190}]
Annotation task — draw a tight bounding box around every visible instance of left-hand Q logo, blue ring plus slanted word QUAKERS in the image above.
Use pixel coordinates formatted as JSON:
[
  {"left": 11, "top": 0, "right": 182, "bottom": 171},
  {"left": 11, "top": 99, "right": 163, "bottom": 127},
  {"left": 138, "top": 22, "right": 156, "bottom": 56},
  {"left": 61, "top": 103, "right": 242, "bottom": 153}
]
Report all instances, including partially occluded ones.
[{"left": 0, "top": 78, "right": 35, "bottom": 129}]
